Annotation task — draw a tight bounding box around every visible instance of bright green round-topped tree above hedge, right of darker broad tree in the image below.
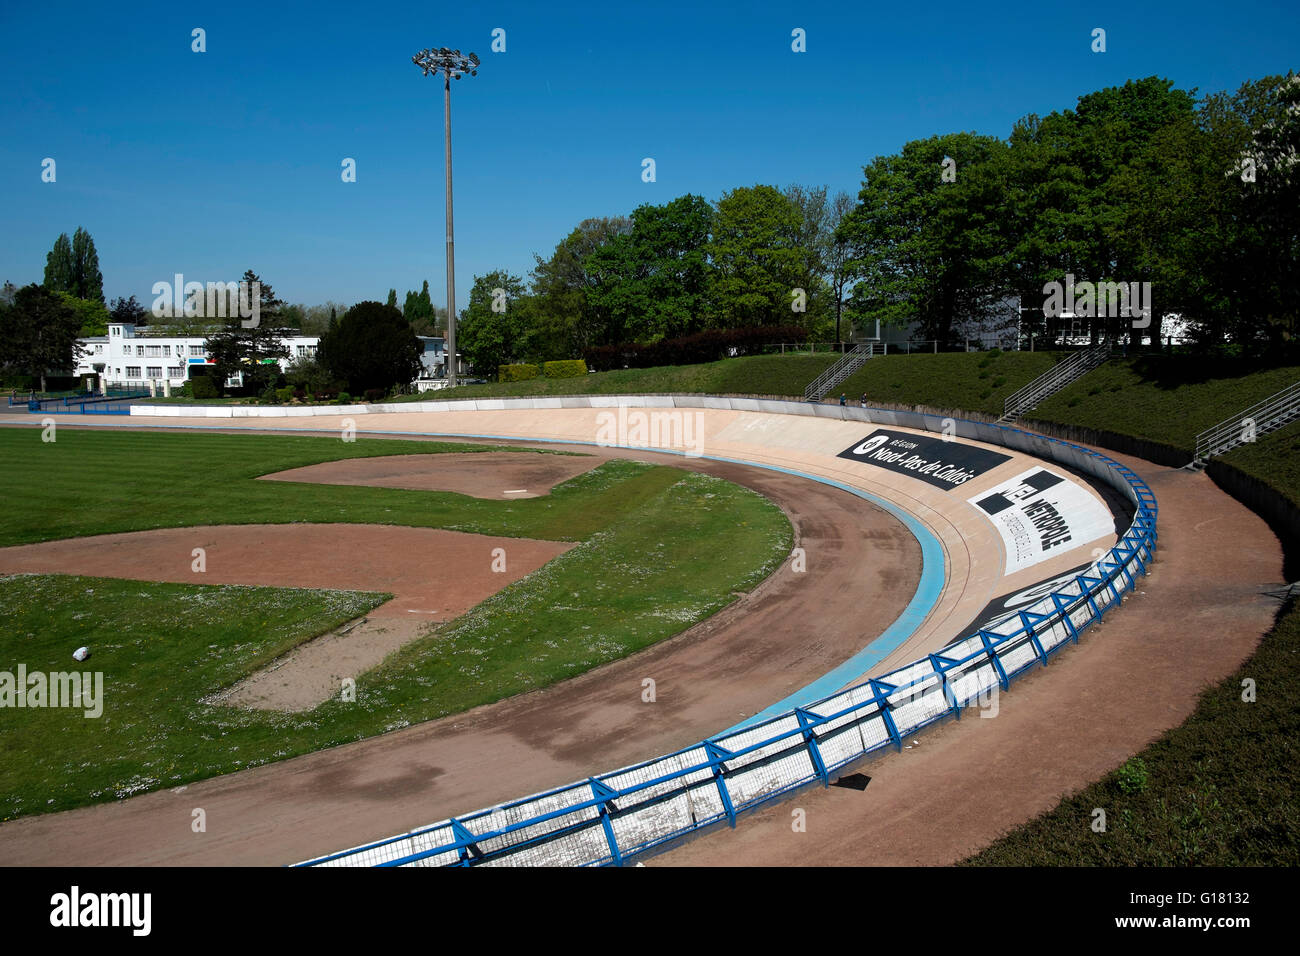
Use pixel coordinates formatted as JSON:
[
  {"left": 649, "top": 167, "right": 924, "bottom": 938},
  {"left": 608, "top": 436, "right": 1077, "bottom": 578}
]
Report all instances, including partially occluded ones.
[{"left": 710, "top": 186, "right": 809, "bottom": 328}]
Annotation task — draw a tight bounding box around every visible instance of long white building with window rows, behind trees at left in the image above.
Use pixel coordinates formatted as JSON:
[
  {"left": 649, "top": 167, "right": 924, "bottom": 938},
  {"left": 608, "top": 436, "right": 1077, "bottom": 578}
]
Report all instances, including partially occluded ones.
[{"left": 75, "top": 323, "right": 320, "bottom": 392}]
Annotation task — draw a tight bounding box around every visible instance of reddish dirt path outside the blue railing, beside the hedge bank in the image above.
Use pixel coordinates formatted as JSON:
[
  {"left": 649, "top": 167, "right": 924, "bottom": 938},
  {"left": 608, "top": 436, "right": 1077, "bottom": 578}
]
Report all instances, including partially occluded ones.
[{"left": 646, "top": 453, "right": 1282, "bottom": 866}]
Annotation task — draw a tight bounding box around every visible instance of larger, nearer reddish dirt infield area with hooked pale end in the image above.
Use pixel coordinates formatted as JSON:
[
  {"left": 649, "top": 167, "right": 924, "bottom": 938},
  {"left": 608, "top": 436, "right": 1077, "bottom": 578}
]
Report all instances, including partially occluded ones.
[{"left": 0, "top": 524, "right": 575, "bottom": 710}]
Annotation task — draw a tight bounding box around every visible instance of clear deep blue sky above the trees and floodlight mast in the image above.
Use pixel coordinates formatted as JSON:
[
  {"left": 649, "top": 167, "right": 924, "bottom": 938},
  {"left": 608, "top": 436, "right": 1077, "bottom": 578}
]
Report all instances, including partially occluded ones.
[{"left": 0, "top": 0, "right": 1300, "bottom": 308}]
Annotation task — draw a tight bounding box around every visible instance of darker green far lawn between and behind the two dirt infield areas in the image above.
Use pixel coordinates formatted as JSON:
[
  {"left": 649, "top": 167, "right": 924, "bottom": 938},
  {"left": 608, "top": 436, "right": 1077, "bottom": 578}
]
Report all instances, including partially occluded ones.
[{"left": 0, "top": 428, "right": 677, "bottom": 546}]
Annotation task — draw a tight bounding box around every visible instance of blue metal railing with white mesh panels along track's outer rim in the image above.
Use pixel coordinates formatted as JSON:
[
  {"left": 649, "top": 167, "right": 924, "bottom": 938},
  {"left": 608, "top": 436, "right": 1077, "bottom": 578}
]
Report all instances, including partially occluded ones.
[{"left": 298, "top": 411, "right": 1157, "bottom": 866}]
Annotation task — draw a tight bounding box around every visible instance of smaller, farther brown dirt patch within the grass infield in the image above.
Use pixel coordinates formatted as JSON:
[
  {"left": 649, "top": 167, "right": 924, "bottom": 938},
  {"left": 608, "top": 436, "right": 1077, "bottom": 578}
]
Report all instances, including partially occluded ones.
[{"left": 263, "top": 451, "right": 603, "bottom": 499}]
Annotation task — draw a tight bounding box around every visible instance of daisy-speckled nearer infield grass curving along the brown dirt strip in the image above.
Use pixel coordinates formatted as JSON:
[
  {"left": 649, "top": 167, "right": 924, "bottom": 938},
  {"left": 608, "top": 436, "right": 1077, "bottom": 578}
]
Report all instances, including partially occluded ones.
[{"left": 0, "top": 463, "right": 793, "bottom": 818}]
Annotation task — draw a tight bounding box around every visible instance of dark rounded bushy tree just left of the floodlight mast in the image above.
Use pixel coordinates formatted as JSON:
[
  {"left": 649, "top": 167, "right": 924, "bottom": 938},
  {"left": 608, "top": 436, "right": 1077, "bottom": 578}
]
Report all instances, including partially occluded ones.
[{"left": 316, "top": 302, "right": 423, "bottom": 394}]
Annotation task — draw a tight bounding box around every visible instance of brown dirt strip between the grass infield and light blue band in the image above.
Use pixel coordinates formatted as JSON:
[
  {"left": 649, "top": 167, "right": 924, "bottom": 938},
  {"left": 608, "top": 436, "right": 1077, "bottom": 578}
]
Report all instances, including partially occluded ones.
[{"left": 0, "top": 449, "right": 920, "bottom": 865}]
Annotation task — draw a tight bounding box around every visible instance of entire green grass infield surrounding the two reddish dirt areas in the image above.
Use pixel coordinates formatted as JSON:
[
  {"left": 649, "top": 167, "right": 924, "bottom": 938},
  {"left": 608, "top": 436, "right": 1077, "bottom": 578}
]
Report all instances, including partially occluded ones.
[{"left": 0, "top": 432, "right": 793, "bottom": 818}]
